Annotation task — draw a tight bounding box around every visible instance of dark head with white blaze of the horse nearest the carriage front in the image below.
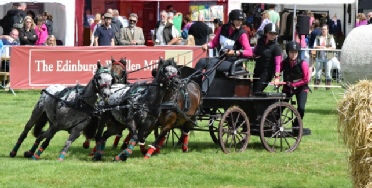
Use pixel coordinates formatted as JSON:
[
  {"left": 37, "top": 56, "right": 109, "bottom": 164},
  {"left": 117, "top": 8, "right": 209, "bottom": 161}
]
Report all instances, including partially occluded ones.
[{"left": 152, "top": 58, "right": 181, "bottom": 88}]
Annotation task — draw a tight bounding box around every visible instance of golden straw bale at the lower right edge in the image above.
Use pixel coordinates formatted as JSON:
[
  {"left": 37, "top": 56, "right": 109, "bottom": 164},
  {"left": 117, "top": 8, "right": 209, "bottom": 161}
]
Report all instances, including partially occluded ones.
[{"left": 338, "top": 80, "right": 372, "bottom": 187}]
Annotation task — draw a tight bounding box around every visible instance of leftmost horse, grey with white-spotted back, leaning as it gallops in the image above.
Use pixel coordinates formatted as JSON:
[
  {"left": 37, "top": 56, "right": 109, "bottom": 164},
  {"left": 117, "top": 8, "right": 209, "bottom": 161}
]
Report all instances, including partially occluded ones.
[{"left": 9, "top": 61, "right": 112, "bottom": 161}]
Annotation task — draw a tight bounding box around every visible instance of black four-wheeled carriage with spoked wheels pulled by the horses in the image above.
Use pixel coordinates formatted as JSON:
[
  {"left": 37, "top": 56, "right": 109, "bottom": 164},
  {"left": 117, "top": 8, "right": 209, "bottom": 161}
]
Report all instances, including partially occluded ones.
[{"left": 172, "top": 58, "right": 303, "bottom": 153}]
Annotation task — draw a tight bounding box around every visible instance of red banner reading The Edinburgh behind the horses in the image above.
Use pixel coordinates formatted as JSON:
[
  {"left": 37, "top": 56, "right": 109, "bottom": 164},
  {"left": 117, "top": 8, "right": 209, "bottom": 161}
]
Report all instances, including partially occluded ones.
[{"left": 10, "top": 46, "right": 206, "bottom": 89}]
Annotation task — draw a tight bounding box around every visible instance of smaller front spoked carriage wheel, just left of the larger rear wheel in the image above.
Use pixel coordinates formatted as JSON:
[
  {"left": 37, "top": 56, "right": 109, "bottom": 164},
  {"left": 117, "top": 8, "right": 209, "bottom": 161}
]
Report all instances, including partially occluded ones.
[{"left": 218, "top": 106, "right": 250, "bottom": 153}]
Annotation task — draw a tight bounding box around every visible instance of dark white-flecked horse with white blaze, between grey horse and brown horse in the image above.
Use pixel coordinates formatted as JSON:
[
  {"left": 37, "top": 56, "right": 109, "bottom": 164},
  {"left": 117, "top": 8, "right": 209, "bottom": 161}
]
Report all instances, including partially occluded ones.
[{"left": 93, "top": 59, "right": 180, "bottom": 161}]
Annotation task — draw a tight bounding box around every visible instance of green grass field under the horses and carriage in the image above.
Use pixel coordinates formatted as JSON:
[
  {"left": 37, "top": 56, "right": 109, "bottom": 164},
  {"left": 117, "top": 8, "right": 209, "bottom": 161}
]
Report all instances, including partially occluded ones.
[{"left": 0, "top": 88, "right": 352, "bottom": 188}]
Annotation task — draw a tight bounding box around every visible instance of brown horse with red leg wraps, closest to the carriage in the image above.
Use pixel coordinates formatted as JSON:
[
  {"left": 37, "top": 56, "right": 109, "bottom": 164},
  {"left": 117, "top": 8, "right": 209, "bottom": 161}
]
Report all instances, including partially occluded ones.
[{"left": 142, "top": 67, "right": 202, "bottom": 159}]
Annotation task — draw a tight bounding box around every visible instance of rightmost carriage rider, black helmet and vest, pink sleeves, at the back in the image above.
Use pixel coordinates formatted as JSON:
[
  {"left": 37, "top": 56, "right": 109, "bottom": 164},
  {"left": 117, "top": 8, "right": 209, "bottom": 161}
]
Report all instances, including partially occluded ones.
[{"left": 280, "top": 41, "right": 309, "bottom": 134}]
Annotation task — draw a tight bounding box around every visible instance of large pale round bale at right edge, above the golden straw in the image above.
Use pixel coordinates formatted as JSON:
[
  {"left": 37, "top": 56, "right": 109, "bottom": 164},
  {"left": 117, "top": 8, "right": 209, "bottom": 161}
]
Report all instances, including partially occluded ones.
[{"left": 341, "top": 25, "right": 372, "bottom": 84}]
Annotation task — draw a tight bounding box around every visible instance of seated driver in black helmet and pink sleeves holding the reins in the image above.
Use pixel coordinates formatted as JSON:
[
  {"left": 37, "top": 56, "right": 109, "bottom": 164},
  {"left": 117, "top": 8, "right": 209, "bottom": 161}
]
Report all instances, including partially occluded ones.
[{"left": 195, "top": 9, "right": 252, "bottom": 95}]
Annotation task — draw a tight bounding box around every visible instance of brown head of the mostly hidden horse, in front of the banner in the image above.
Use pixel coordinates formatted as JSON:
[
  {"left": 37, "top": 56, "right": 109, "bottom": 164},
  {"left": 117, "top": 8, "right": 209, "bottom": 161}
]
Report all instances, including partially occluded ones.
[{"left": 111, "top": 57, "right": 127, "bottom": 84}]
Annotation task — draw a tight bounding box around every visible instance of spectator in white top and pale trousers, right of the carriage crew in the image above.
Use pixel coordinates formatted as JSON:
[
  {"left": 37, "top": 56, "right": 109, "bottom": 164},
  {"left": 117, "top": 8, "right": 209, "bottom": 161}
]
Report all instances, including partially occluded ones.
[{"left": 314, "top": 24, "right": 336, "bottom": 90}]
